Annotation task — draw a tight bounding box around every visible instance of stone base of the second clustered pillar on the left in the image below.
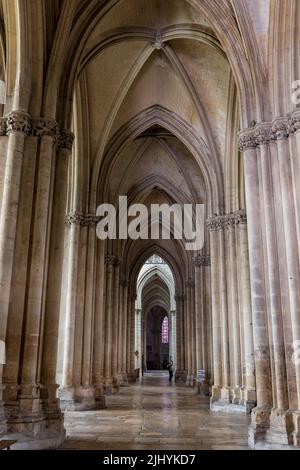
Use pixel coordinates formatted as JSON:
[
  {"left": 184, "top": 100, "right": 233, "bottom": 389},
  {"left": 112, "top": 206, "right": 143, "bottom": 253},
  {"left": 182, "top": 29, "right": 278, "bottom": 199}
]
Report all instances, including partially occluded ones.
[{"left": 58, "top": 386, "right": 103, "bottom": 411}]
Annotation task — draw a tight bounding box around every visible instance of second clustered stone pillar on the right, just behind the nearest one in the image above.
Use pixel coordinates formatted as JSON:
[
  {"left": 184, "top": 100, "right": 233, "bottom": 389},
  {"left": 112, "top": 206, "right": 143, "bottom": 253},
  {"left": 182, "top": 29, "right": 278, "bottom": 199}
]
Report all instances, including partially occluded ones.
[{"left": 208, "top": 211, "right": 256, "bottom": 412}]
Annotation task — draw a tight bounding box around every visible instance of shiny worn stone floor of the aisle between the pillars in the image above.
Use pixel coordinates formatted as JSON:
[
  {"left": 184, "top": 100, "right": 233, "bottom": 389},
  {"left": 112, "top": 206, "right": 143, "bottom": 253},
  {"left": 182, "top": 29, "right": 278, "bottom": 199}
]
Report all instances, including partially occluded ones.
[{"left": 62, "top": 374, "right": 248, "bottom": 450}]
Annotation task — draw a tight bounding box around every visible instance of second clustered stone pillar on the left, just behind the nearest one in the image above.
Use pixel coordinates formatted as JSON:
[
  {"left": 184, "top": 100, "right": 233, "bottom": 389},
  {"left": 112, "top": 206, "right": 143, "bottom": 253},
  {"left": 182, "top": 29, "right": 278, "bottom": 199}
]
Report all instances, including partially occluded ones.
[{"left": 59, "top": 211, "right": 99, "bottom": 410}]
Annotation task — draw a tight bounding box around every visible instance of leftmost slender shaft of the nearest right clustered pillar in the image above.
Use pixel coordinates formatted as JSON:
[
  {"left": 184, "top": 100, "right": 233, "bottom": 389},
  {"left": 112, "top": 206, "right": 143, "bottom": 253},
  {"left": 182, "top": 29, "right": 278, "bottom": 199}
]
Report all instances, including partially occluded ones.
[{"left": 239, "top": 129, "right": 272, "bottom": 447}]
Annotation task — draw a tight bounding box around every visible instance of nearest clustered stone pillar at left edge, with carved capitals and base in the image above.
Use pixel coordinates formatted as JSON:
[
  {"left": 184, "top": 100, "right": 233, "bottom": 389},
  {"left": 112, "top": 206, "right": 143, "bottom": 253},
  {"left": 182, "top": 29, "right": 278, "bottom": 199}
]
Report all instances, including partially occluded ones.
[{"left": 0, "top": 111, "right": 73, "bottom": 448}]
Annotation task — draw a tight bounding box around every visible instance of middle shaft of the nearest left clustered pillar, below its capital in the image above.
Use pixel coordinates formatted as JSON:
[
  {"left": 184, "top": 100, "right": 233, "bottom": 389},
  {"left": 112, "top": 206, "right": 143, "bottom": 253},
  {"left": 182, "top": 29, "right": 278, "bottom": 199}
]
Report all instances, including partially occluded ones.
[{"left": 19, "top": 132, "right": 55, "bottom": 413}]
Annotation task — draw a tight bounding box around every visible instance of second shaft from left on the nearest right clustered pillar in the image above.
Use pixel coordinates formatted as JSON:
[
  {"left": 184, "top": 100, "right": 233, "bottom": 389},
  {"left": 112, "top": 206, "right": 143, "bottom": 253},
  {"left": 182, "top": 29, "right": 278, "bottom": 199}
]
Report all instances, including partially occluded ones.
[{"left": 256, "top": 124, "right": 291, "bottom": 444}]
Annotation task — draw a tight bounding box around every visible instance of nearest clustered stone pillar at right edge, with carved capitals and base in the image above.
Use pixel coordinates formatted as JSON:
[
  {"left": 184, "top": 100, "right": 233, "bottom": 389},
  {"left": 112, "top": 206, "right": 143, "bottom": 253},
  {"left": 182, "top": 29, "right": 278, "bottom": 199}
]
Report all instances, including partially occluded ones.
[{"left": 239, "top": 111, "right": 300, "bottom": 448}]
